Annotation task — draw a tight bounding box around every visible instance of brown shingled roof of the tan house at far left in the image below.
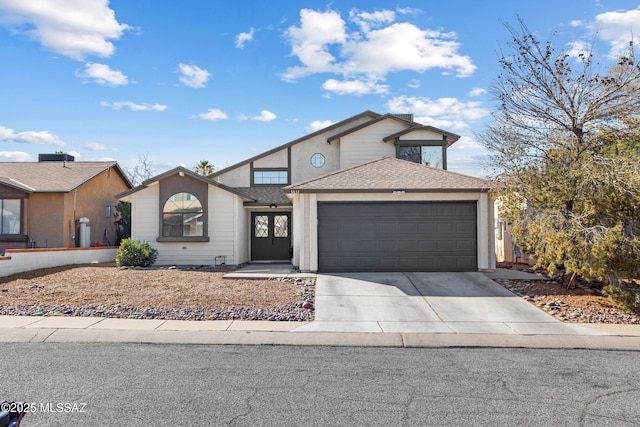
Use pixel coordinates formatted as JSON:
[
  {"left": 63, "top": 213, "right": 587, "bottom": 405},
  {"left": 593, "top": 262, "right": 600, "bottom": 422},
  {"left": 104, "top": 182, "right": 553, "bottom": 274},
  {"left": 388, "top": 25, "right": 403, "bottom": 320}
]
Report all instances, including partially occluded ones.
[{"left": 0, "top": 161, "right": 132, "bottom": 193}]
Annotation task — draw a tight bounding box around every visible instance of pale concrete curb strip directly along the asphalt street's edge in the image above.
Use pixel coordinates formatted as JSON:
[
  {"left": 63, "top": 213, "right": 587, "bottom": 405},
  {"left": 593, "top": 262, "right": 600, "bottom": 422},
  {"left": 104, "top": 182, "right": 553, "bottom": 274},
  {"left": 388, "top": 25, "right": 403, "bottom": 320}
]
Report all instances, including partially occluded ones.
[{"left": 0, "top": 328, "right": 640, "bottom": 351}]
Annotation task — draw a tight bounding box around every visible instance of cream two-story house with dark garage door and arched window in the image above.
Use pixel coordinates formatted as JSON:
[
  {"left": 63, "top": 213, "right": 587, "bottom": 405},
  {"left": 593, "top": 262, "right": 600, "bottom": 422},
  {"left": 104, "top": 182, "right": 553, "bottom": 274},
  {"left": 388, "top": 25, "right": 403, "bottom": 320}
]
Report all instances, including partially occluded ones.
[{"left": 117, "top": 111, "right": 495, "bottom": 271}]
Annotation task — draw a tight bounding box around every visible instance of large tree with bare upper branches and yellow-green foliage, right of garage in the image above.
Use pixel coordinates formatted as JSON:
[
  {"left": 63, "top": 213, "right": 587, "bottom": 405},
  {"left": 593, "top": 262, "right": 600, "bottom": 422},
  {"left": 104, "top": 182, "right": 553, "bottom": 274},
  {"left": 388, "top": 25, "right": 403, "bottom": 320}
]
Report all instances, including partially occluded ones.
[{"left": 480, "top": 18, "right": 640, "bottom": 290}]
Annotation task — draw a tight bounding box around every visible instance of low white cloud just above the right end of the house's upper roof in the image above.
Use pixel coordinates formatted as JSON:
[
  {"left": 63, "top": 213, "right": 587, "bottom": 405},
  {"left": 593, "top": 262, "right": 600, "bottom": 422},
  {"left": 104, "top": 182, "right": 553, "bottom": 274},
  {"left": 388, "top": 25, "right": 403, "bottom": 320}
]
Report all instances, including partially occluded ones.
[{"left": 387, "top": 96, "right": 490, "bottom": 130}]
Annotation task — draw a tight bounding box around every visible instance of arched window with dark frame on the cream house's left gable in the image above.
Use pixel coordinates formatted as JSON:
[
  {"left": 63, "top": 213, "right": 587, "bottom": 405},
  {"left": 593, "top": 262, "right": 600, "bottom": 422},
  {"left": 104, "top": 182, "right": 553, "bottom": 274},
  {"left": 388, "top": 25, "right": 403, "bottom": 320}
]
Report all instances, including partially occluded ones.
[{"left": 162, "top": 193, "right": 204, "bottom": 237}]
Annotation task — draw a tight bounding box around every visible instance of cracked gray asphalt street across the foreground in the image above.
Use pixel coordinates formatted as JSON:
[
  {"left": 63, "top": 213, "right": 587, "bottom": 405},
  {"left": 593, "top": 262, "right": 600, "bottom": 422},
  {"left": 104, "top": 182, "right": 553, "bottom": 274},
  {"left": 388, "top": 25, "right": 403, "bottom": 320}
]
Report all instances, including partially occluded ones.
[{"left": 0, "top": 343, "right": 640, "bottom": 427}]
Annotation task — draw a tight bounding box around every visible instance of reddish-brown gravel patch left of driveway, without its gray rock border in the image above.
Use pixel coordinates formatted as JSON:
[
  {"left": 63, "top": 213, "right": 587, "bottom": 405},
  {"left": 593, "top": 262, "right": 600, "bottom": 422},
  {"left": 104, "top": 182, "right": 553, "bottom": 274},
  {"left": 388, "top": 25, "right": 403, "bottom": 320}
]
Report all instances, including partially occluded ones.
[{"left": 0, "top": 263, "right": 300, "bottom": 309}]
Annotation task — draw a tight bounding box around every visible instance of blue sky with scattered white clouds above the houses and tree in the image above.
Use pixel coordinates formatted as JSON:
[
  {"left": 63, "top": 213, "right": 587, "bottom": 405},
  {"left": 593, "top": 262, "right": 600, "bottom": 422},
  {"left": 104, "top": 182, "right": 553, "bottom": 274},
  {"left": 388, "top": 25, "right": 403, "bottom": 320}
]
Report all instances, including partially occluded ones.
[{"left": 0, "top": 0, "right": 640, "bottom": 177}]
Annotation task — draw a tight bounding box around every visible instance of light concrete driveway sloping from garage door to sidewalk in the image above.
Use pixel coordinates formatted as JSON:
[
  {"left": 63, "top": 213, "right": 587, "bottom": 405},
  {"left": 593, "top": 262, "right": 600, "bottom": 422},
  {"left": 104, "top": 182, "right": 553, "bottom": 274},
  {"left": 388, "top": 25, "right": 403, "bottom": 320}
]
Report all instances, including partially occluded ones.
[{"left": 295, "top": 272, "right": 605, "bottom": 335}]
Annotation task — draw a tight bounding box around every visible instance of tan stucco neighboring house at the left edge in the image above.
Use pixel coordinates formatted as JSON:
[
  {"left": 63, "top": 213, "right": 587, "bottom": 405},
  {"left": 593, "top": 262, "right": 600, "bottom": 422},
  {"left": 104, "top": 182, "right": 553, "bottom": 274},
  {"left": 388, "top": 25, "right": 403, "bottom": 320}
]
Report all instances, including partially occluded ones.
[{"left": 0, "top": 154, "right": 132, "bottom": 252}]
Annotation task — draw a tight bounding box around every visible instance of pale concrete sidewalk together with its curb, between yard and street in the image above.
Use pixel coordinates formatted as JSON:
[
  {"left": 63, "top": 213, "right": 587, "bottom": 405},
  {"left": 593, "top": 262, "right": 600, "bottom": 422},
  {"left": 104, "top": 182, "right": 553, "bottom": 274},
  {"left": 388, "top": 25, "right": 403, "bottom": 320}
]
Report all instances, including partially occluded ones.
[{"left": 0, "top": 316, "right": 640, "bottom": 351}]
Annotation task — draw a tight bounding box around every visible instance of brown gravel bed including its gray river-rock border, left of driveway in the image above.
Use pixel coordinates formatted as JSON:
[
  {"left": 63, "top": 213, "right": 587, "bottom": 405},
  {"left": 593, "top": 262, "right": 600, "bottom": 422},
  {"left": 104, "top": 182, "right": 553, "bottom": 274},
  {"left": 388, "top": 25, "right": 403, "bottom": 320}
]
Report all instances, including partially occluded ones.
[{"left": 0, "top": 263, "right": 315, "bottom": 321}]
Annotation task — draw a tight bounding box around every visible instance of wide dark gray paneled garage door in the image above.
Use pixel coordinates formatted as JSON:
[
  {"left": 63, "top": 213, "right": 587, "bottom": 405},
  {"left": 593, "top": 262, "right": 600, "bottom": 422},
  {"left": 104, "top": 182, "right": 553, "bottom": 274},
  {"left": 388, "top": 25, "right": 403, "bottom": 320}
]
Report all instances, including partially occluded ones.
[{"left": 318, "top": 202, "right": 478, "bottom": 272}]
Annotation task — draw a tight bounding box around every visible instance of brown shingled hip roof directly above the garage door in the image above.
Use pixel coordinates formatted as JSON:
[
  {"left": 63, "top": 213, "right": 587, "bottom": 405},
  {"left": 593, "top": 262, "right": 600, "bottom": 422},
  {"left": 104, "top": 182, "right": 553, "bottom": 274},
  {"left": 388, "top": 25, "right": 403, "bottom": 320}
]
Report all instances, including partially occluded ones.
[{"left": 283, "top": 157, "right": 491, "bottom": 193}]
